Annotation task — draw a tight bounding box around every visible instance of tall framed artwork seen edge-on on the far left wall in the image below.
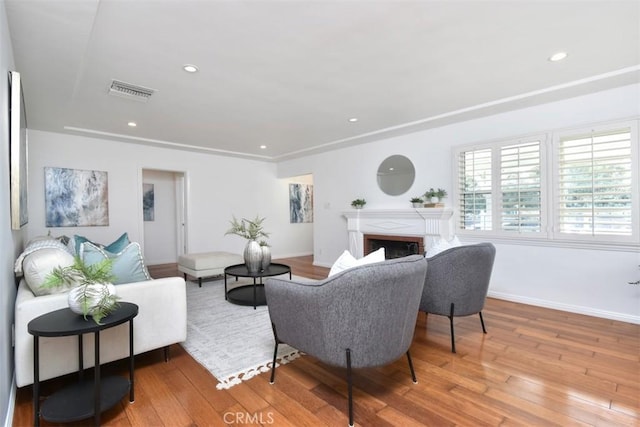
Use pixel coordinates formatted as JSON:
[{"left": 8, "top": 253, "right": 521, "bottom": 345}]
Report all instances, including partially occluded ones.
[{"left": 9, "top": 71, "right": 29, "bottom": 230}]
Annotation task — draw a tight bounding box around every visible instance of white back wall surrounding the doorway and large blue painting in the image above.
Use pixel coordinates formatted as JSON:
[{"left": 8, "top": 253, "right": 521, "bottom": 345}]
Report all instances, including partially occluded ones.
[{"left": 28, "top": 131, "right": 312, "bottom": 258}]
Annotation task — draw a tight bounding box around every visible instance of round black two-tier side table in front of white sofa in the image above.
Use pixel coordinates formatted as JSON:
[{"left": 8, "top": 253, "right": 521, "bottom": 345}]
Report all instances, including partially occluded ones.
[{"left": 27, "top": 302, "right": 138, "bottom": 426}]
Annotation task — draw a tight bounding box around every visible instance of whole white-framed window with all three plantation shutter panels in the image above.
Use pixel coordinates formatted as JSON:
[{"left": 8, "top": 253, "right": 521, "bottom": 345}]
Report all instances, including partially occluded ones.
[{"left": 454, "top": 121, "right": 640, "bottom": 244}]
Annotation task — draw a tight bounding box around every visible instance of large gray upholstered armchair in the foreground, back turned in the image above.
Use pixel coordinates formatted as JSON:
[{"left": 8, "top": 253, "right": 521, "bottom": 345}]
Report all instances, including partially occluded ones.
[{"left": 265, "top": 255, "right": 427, "bottom": 425}]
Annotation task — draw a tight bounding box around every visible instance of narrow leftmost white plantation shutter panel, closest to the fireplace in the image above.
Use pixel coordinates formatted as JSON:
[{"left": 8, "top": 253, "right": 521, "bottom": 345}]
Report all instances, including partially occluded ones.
[{"left": 458, "top": 148, "right": 492, "bottom": 230}]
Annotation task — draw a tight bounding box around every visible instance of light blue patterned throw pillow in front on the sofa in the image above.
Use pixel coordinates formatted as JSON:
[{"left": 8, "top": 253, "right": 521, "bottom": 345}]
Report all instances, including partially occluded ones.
[{"left": 80, "top": 242, "right": 151, "bottom": 285}]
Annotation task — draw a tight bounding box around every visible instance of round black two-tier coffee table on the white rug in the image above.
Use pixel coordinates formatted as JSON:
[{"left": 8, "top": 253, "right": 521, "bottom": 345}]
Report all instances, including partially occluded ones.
[{"left": 224, "top": 263, "right": 291, "bottom": 310}]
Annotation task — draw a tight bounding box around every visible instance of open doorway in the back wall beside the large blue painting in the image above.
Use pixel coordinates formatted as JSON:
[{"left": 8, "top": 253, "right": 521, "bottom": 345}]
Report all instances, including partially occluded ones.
[{"left": 142, "top": 169, "right": 187, "bottom": 265}]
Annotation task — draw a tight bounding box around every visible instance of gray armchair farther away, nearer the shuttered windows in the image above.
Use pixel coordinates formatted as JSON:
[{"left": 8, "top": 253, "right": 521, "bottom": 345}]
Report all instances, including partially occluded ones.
[{"left": 420, "top": 243, "right": 496, "bottom": 353}]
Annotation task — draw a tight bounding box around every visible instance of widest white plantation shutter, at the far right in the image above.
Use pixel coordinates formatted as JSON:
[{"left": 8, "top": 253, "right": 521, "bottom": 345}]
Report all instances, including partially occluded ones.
[{"left": 557, "top": 128, "right": 637, "bottom": 236}]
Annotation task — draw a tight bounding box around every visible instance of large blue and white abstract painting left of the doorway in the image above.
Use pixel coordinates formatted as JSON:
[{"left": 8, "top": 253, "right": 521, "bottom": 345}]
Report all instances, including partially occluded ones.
[{"left": 44, "top": 168, "right": 109, "bottom": 227}]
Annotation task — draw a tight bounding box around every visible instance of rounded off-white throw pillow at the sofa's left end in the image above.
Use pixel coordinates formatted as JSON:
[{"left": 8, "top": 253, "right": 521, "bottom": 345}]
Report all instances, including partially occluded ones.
[{"left": 22, "top": 248, "right": 73, "bottom": 296}]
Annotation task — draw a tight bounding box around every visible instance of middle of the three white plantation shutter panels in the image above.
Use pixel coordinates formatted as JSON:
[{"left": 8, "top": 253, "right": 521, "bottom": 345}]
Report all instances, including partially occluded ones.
[{"left": 500, "top": 141, "right": 542, "bottom": 233}]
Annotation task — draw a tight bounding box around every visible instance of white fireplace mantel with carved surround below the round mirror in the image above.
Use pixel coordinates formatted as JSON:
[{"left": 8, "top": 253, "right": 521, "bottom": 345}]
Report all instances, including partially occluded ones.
[{"left": 342, "top": 207, "right": 453, "bottom": 258}]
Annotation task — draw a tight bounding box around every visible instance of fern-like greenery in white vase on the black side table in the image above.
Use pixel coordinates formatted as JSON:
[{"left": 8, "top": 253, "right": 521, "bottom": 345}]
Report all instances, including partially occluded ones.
[{"left": 42, "top": 256, "right": 118, "bottom": 324}]
